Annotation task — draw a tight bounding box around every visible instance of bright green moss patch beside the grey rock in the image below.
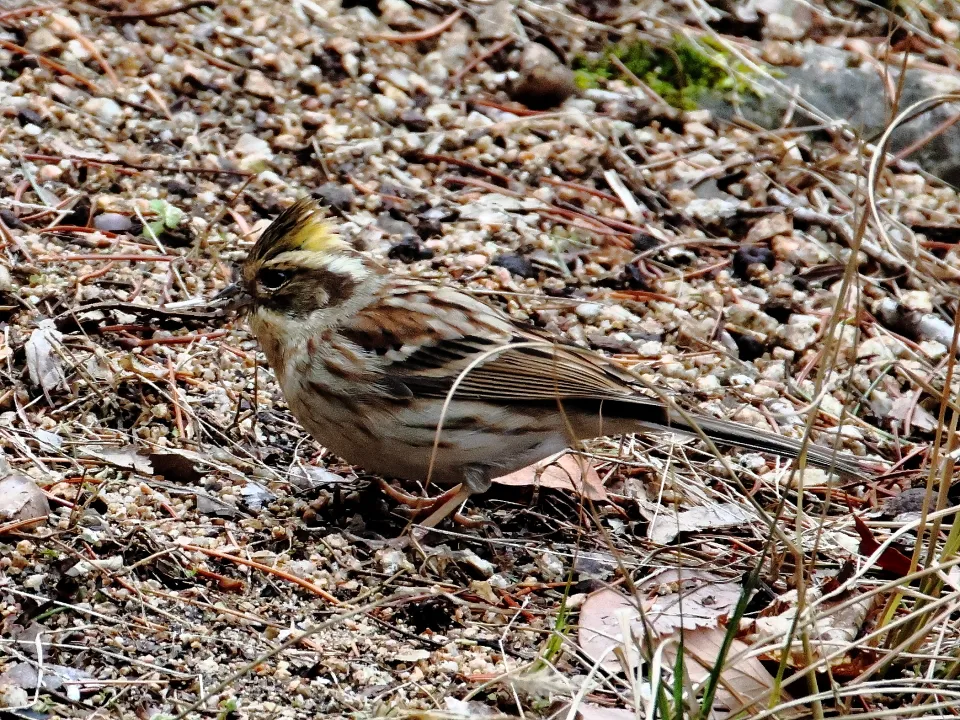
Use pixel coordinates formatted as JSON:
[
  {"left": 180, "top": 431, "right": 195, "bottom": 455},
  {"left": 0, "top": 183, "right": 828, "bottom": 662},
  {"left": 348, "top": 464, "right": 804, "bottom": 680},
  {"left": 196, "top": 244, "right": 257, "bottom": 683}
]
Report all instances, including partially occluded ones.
[{"left": 573, "top": 37, "right": 751, "bottom": 110}]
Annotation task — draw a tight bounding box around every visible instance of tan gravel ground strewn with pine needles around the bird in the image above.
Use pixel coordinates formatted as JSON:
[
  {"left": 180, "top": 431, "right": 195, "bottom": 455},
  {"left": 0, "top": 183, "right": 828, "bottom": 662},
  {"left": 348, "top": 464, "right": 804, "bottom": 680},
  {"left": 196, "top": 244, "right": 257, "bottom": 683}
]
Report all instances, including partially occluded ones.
[{"left": 0, "top": 0, "right": 960, "bottom": 718}]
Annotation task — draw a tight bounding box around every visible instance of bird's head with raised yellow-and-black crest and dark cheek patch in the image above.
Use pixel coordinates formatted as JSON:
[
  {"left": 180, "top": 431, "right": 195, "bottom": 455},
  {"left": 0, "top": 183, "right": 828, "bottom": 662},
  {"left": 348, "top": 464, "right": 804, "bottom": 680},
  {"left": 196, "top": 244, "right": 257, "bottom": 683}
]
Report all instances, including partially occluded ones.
[{"left": 219, "top": 198, "right": 377, "bottom": 324}]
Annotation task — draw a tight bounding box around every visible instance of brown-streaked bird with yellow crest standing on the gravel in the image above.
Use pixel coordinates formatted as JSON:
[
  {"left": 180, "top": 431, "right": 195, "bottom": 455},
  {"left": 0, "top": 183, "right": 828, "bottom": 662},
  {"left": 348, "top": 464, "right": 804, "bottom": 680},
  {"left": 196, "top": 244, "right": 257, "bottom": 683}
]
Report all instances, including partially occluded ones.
[{"left": 217, "top": 197, "right": 864, "bottom": 527}]
